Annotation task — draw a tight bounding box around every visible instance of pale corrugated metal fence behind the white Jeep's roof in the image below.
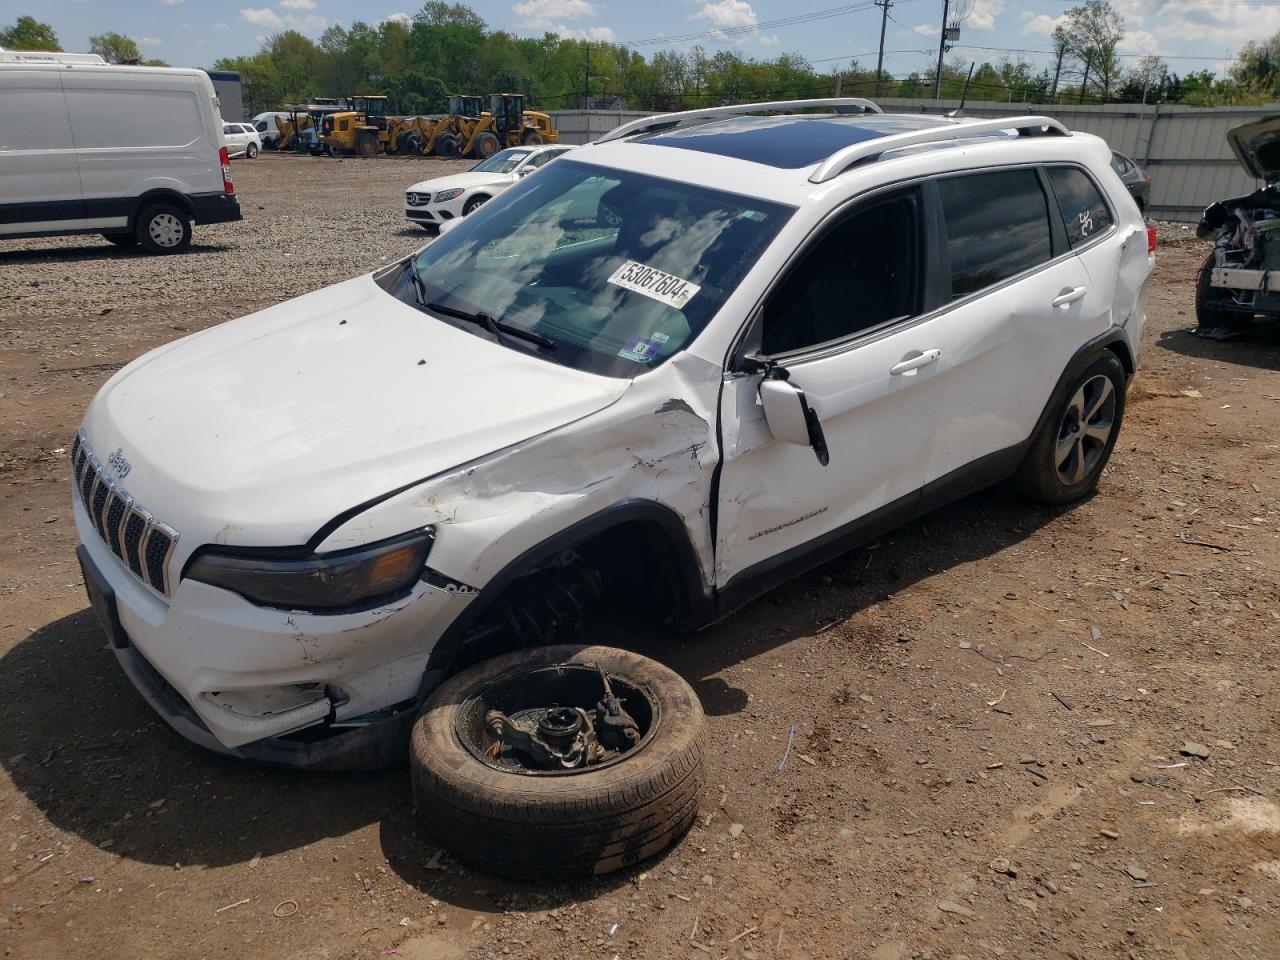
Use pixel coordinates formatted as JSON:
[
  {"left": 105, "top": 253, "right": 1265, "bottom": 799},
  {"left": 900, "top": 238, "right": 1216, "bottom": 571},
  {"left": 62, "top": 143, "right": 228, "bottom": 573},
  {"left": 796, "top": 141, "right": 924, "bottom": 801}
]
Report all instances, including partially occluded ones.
[{"left": 553, "top": 99, "right": 1280, "bottom": 220}]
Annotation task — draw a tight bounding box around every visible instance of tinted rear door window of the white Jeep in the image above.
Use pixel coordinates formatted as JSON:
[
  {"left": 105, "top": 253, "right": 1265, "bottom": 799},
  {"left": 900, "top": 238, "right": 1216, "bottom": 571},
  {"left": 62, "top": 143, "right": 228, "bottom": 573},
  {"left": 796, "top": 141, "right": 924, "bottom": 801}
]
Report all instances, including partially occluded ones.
[{"left": 938, "top": 170, "right": 1052, "bottom": 300}]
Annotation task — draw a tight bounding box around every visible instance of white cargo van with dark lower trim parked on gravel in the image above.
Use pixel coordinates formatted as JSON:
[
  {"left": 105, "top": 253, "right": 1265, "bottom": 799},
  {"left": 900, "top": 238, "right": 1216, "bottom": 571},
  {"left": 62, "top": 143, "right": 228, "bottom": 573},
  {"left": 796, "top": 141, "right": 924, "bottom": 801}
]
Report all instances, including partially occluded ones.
[{"left": 0, "top": 51, "right": 241, "bottom": 253}]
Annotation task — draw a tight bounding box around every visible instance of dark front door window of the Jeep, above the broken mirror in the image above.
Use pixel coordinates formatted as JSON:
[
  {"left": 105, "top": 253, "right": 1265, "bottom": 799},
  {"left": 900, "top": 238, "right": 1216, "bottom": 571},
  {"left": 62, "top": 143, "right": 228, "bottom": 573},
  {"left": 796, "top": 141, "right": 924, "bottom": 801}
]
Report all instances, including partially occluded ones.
[{"left": 760, "top": 189, "right": 920, "bottom": 355}]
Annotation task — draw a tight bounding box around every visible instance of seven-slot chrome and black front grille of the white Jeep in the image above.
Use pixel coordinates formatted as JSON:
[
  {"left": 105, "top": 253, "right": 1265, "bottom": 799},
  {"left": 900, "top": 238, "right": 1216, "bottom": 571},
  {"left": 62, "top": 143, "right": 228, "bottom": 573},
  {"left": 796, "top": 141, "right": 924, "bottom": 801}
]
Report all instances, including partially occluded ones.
[{"left": 72, "top": 433, "right": 178, "bottom": 596}]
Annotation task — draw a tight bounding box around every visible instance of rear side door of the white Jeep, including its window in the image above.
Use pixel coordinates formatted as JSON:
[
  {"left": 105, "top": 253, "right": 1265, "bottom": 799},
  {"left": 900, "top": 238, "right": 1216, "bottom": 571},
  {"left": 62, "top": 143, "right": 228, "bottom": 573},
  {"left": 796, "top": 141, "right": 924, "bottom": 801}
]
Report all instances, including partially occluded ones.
[{"left": 925, "top": 166, "right": 1089, "bottom": 488}]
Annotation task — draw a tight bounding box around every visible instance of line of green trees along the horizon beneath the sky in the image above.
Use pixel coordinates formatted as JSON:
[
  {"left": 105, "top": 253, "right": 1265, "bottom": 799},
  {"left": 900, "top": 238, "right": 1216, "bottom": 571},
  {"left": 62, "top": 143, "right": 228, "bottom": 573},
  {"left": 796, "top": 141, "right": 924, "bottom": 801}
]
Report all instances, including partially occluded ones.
[{"left": 0, "top": 0, "right": 1280, "bottom": 114}]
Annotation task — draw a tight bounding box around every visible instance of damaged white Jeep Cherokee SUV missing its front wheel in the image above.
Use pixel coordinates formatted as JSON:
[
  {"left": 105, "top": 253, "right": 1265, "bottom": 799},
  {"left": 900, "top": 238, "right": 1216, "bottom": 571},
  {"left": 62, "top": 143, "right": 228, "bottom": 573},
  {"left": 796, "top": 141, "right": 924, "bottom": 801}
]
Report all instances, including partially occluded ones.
[{"left": 67, "top": 100, "right": 1149, "bottom": 767}]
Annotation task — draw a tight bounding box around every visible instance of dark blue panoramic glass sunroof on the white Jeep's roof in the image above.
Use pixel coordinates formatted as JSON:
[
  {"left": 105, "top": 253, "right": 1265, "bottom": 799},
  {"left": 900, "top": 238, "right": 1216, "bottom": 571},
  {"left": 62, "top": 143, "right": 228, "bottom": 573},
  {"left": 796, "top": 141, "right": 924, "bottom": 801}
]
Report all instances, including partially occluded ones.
[{"left": 639, "top": 114, "right": 940, "bottom": 169}]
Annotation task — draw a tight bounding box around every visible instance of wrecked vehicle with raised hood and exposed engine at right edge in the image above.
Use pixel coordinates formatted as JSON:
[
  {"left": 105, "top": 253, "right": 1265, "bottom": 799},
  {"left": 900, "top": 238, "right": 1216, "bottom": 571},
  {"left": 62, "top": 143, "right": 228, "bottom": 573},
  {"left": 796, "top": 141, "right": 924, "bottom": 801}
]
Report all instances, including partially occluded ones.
[{"left": 1196, "top": 116, "right": 1280, "bottom": 332}]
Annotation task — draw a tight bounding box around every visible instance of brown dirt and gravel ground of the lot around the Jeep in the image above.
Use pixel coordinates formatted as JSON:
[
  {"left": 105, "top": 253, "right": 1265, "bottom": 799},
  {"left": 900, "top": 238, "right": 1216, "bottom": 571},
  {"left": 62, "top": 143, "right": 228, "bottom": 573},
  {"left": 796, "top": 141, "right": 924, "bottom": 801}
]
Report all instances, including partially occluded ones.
[{"left": 0, "top": 156, "right": 1280, "bottom": 960}]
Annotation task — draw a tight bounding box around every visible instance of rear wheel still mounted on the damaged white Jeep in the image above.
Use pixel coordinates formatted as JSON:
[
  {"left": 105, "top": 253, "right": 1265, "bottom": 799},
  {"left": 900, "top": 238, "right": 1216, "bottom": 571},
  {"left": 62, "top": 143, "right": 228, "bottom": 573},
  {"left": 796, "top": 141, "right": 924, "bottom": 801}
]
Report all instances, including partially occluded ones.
[{"left": 1014, "top": 351, "right": 1126, "bottom": 506}]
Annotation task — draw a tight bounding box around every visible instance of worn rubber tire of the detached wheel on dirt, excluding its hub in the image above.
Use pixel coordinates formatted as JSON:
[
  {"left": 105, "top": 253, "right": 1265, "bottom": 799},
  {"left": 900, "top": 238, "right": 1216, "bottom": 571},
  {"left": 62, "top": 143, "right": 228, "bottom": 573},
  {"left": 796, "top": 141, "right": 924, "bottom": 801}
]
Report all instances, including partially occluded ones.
[{"left": 410, "top": 645, "right": 707, "bottom": 879}]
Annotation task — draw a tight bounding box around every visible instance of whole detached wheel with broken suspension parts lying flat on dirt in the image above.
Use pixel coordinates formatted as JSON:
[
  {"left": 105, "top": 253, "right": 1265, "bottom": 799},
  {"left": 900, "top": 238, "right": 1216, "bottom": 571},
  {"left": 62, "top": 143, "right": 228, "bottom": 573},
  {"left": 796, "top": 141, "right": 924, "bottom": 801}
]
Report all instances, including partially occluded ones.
[{"left": 410, "top": 645, "right": 707, "bottom": 879}]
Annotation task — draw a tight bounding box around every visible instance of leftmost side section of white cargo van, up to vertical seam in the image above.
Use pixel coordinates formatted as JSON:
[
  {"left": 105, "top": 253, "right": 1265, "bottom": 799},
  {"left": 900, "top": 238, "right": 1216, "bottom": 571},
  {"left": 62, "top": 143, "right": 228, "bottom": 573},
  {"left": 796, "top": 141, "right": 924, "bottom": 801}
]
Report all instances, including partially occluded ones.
[{"left": 0, "top": 67, "right": 84, "bottom": 236}]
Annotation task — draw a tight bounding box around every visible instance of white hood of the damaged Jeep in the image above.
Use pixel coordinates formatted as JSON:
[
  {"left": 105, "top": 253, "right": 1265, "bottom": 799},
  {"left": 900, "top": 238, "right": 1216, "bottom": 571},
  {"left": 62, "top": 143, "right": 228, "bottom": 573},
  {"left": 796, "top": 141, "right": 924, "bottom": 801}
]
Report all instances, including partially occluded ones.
[{"left": 84, "top": 276, "right": 627, "bottom": 553}]
